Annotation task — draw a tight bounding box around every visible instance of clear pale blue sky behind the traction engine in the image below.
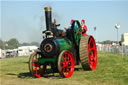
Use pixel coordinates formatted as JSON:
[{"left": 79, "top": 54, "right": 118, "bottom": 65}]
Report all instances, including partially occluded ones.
[{"left": 0, "top": 0, "right": 128, "bottom": 42}]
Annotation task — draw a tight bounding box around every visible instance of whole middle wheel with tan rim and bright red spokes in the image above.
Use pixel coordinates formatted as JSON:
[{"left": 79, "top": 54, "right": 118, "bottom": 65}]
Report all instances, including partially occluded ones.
[{"left": 58, "top": 50, "right": 74, "bottom": 78}]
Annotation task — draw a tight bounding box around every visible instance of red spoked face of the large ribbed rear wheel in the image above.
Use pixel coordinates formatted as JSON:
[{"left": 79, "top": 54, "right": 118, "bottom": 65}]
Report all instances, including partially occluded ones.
[{"left": 88, "top": 37, "right": 97, "bottom": 70}]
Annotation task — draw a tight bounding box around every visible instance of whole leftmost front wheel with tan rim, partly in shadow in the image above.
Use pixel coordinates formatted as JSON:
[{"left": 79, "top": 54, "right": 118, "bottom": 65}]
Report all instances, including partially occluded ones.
[{"left": 29, "top": 52, "right": 46, "bottom": 78}]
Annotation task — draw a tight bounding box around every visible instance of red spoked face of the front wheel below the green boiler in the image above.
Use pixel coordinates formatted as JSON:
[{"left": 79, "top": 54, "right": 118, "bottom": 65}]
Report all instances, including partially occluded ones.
[{"left": 61, "top": 51, "right": 74, "bottom": 78}]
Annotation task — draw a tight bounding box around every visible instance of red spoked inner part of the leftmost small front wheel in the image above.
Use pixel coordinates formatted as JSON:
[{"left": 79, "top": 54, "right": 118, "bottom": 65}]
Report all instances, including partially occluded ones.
[{"left": 32, "top": 55, "right": 46, "bottom": 78}]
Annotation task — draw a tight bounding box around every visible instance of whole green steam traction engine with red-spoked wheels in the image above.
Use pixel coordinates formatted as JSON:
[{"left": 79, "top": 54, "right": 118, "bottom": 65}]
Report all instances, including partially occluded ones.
[{"left": 29, "top": 7, "right": 97, "bottom": 78}]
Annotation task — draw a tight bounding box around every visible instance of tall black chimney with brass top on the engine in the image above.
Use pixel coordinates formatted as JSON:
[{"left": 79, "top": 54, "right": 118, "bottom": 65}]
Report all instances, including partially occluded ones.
[{"left": 44, "top": 7, "right": 52, "bottom": 31}]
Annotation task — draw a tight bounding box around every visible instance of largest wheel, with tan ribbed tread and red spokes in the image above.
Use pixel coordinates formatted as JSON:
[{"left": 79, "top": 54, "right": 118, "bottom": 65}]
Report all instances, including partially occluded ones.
[{"left": 79, "top": 35, "right": 97, "bottom": 70}]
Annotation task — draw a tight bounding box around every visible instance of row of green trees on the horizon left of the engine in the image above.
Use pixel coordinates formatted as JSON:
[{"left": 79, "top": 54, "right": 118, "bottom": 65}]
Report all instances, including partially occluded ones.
[{"left": 0, "top": 38, "right": 40, "bottom": 49}]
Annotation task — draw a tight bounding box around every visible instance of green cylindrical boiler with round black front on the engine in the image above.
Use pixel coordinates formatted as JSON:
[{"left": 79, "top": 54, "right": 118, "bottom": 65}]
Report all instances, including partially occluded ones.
[{"left": 40, "top": 38, "right": 72, "bottom": 57}]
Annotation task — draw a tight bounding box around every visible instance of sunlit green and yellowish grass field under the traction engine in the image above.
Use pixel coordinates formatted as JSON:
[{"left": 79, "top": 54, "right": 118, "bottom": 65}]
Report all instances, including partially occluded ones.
[{"left": 0, "top": 52, "right": 128, "bottom": 85}]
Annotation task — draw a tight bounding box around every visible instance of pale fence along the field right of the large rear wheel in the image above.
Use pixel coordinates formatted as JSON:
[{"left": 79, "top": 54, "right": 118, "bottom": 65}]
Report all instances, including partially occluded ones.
[{"left": 97, "top": 45, "right": 128, "bottom": 55}]
